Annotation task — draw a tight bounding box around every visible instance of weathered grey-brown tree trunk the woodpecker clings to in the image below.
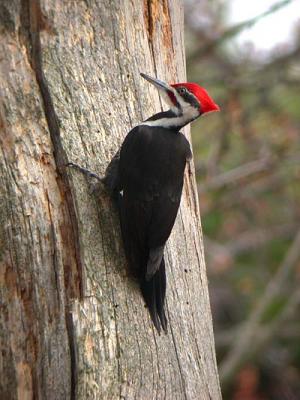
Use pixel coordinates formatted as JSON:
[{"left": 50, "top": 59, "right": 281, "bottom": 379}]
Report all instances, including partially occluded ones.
[{"left": 0, "top": 0, "right": 221, "bottom": 400}]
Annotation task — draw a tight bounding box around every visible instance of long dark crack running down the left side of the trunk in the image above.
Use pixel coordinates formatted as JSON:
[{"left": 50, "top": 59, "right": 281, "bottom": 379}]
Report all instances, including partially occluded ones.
[{"left": 20, "top": 0, "right": 84, "bottom": 400}]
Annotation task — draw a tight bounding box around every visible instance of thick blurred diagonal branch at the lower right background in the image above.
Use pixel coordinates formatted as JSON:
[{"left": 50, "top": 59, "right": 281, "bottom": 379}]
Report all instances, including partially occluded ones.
[{"left": 220, "top": 230, "right": 300, "bottom": 384}]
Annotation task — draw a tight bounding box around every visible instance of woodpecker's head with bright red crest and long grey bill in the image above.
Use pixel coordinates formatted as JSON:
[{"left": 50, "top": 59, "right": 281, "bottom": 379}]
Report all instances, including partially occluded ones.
[{"left": 141, "top": 73, "right": 220, "bottom": 123}]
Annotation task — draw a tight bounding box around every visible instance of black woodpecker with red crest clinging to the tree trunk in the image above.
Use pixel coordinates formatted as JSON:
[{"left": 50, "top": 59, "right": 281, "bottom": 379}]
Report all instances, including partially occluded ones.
[{"left": 70, "top": 74, "right": 219, "bottom": 332}]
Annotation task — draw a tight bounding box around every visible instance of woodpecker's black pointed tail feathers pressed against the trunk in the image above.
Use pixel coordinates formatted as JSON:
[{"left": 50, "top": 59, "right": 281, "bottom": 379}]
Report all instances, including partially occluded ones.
[{"left": 141, "top": 257, "right": 167, "bottom": 333}]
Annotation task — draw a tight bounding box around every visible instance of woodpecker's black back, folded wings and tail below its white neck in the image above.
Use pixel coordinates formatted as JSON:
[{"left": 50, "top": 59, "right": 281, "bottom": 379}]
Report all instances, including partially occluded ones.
[{"left": 119, "top": 126, "right": 190, "bottom": 331}]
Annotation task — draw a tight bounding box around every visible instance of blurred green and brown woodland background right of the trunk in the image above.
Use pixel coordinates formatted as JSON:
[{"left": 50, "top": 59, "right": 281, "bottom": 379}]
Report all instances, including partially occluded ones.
[{"left": 184, "top": 0, "right": 300, "bottom": 400}]
